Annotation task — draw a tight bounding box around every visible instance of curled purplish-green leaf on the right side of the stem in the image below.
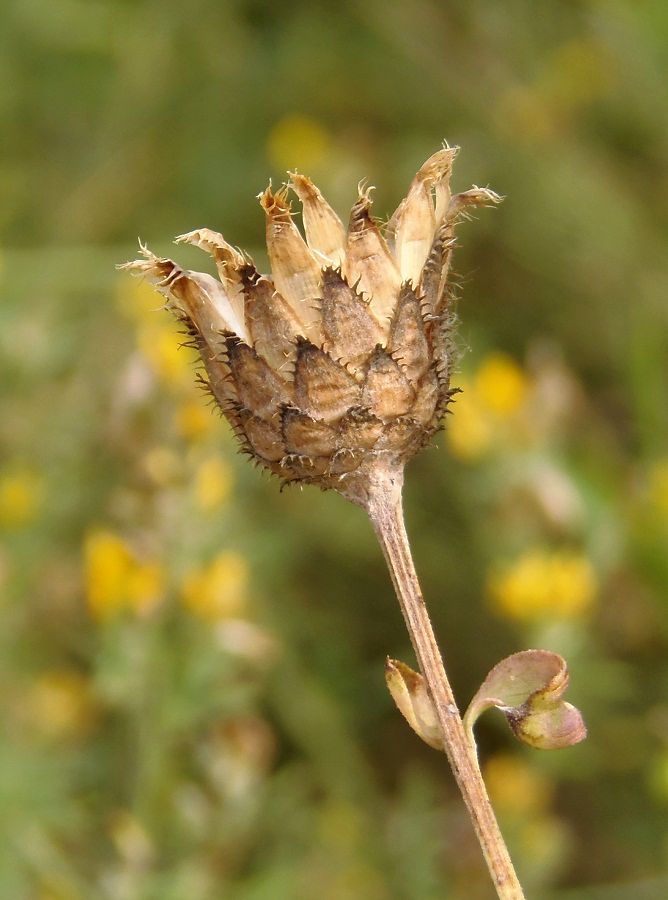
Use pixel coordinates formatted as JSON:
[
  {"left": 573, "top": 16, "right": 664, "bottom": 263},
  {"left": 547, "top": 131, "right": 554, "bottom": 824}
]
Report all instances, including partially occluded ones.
[{"left": 464, "top": 650, "right": 587, "bottom": 750}]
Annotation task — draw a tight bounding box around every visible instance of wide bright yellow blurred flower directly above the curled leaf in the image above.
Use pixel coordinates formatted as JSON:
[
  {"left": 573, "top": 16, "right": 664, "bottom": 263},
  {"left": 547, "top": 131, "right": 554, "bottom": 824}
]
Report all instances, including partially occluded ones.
[{"left": 488, "top": 549, "right": 598, "bottom": 620}]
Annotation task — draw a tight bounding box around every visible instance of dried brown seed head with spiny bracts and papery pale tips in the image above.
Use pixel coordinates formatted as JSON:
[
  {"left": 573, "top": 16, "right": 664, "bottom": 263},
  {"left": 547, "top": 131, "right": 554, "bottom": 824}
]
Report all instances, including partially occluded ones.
[{"left": 122, "top": 147, "right": 500, "bottom": 502}]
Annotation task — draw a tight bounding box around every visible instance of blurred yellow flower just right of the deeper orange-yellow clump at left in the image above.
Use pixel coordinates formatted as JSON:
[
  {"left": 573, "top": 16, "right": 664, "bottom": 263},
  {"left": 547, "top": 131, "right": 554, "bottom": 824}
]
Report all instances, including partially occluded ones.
[{"left": 181, "top": 551, "right": 248, "bottom": 621}]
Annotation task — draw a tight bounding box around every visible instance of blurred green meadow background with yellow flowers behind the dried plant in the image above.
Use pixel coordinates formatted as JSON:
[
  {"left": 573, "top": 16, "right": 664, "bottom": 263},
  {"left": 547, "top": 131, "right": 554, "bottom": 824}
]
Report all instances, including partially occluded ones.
[{"left": 0, "top": 0, "right": 668, "bottom": 900}]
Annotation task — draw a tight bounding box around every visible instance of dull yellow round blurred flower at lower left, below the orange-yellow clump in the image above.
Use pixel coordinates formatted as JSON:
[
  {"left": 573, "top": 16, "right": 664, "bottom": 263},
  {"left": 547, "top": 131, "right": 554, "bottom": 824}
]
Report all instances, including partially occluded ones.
[{"left": 27, "top": 669, "right": 94, "bottom": 738}]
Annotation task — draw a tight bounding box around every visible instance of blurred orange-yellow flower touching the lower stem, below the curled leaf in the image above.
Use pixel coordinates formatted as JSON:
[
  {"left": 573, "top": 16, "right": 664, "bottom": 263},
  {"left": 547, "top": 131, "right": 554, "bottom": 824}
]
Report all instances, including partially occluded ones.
[{"left": 484, "top": 753, "right": 554, "bottom": 818}]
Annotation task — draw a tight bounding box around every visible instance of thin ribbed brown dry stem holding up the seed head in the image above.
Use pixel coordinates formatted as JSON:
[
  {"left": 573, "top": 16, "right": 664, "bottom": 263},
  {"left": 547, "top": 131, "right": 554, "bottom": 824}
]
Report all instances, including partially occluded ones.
[{"left": 362, "top": 469, "right": 524, "bottom": 900}]
